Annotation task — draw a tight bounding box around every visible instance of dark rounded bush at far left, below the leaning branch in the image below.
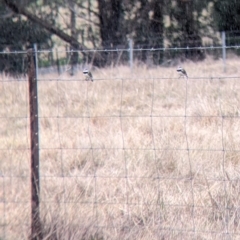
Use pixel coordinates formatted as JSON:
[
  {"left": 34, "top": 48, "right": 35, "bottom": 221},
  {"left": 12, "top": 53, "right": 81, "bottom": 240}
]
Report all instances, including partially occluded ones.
[{"left": 0, "top": 18, "right": 51, "bottom": 75}]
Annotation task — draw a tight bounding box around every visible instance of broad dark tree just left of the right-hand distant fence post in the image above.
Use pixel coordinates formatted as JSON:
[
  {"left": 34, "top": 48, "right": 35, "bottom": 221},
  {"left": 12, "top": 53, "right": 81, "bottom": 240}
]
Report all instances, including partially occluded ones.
[{"left": 165, "top": 0, "right": 215, "bottom": 60}]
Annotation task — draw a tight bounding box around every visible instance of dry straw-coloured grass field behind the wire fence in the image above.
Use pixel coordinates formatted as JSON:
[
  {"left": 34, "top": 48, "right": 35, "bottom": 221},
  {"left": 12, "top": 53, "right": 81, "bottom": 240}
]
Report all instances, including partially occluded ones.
[{"left": 0, "top": 55, "right": 240, "bottom": 240}]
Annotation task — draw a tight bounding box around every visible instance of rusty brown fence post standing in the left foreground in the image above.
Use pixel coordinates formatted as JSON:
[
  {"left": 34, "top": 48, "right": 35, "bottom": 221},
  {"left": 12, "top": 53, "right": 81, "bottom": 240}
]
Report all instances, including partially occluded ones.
[{"left": 27, "top": 47, "right": 42, "bottom": 240}]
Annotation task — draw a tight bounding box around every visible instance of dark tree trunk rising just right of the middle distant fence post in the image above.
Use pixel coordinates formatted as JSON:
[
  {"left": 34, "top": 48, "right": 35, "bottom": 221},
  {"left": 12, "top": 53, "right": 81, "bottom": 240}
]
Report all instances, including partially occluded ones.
[{"left": 124, "top": 0, "right": 165, "bottom": 64}]
